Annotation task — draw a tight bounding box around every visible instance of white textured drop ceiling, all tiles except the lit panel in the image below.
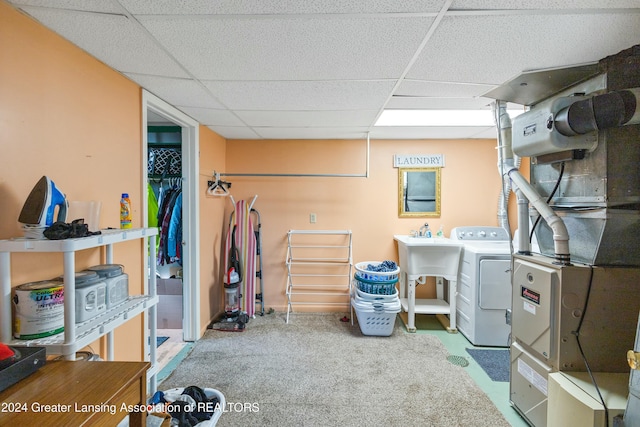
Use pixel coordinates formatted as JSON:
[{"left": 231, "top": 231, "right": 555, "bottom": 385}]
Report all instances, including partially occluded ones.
[{"left": 8, "top": 0, "right": 640, "bottom": 139}]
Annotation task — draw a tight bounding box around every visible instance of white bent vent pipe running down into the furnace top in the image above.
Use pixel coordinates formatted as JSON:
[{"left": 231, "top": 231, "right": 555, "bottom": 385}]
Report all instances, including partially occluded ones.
[{"left": 496, "top": 101, "right": 571, "bottom": 265}]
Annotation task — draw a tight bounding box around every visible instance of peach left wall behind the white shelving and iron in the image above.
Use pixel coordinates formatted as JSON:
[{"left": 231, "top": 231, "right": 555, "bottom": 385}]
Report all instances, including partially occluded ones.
[{"left": 0, "top": 2, "right": 143, "bottom": 360}]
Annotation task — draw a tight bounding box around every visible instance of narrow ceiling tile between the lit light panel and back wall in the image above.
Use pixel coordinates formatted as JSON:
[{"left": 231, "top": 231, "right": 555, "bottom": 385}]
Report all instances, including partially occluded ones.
[{"left": 369, "top": 126, "right": 495, "bottom": 139}]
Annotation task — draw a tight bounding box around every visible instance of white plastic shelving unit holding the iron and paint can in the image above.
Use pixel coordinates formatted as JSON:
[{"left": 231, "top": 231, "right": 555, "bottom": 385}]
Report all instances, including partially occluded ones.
[{"left": 0, "top": 228, "right": 158, "bottom": 392}]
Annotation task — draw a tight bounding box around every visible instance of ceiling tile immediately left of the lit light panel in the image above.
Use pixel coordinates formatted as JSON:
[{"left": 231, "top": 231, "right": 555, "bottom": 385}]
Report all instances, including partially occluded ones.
[{"left": 236, "top": 110, "right": 378, "bottom": 127}]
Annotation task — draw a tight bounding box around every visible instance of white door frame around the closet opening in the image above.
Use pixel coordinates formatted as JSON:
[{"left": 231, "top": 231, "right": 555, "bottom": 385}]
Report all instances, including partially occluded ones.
[{"left": 142, "top": 89, "right": 200, "bottom": 341}]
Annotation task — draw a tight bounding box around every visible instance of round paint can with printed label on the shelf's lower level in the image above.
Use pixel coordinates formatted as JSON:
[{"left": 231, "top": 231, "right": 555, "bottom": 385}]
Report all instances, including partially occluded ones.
[{"left": 13, "top": 280, "right": 64, "bottom": 340}]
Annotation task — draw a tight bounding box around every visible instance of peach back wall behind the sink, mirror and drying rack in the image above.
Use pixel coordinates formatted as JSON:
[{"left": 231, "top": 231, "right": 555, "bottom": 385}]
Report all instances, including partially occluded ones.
[{"left": 226, "top": 139, "right": 515, "bottom": 310}]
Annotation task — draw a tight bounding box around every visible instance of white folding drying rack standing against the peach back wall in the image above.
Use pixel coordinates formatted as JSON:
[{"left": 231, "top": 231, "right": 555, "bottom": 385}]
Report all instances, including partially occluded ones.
[{"left": 286, "top": 230, "right": 353, "bottom": 323}]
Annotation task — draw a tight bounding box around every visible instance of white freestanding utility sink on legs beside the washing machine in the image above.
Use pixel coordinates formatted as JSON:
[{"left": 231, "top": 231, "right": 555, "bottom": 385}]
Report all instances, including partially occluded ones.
[{"left": 393, "top": 234, "right": 463, "bottom": 332}]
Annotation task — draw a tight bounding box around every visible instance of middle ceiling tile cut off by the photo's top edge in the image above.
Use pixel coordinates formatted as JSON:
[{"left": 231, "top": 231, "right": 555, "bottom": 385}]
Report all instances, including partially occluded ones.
[{"left": 120, "top": 0, "right": 444, "bottom": 15}]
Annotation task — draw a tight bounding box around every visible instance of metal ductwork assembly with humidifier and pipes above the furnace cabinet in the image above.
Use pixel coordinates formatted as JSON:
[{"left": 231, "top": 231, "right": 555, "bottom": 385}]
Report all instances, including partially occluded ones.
[{"left": 485, "top": 45, "right": 640, "bottom": 266}]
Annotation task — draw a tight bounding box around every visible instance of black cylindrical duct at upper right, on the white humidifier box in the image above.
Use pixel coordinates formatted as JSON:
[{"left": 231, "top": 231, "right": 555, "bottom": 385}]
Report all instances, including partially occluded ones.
[{"left": 554, "top": 88, "right": 640, "bottom": 136}]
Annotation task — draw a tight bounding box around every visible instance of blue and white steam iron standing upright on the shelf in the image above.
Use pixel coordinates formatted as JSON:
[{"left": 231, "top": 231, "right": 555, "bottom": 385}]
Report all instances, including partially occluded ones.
[{"left": 18, "top": 176, "right": 69, "bottom": 228}]
